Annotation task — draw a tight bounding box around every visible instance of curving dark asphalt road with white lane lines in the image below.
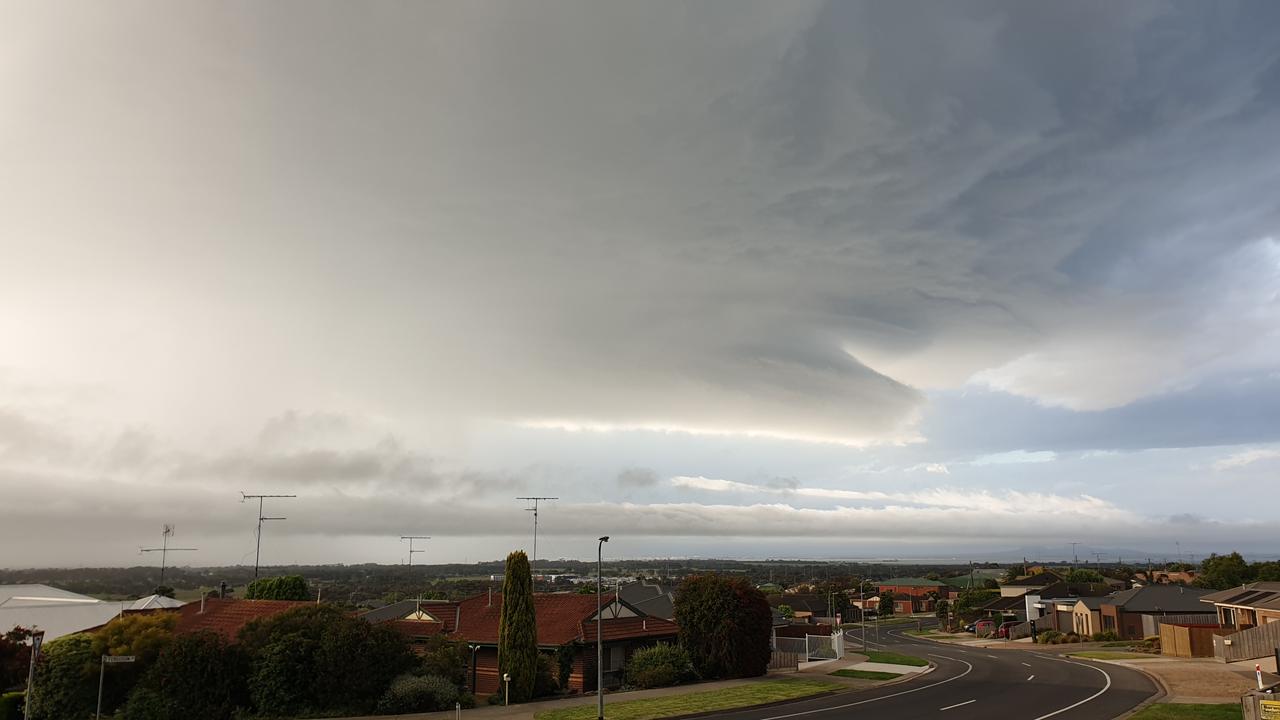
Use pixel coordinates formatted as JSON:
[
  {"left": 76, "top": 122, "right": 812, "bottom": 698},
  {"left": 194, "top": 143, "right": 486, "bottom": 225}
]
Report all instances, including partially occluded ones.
[{"left": 716, "top": 625, "right": 1157, "bottom": 720}]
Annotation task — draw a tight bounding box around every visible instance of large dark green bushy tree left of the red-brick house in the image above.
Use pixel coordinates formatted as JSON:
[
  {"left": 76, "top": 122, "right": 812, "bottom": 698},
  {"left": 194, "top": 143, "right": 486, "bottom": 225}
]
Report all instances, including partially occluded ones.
[{"left": 239, "top": 605, "right": 413, "bottom": 716}]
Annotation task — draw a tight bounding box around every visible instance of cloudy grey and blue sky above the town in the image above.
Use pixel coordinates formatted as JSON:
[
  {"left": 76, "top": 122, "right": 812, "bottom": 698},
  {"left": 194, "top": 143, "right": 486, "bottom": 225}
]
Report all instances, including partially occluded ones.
[{"left": 0, "top": 0, "right": 1280, "bottom": 568}]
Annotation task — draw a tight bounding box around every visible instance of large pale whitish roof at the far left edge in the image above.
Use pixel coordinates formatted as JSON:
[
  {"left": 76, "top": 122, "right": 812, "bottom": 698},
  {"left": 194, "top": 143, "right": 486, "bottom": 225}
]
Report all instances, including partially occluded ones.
[{"left": 0, "top": 584, "right": 124, "bottom": 642}]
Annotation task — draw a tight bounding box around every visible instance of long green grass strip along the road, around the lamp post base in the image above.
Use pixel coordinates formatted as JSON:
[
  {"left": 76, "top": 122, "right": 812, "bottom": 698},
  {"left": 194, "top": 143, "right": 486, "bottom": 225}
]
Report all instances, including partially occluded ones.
[{"left": 534, "top": 680, "right": 844, "bottom": 720}]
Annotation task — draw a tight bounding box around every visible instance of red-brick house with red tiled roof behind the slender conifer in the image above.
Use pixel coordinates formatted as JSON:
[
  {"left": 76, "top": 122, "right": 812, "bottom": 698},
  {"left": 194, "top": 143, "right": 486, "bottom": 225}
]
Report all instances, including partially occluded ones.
[{"left": 361, "top": 592, "right": 678, "bottom": 694}]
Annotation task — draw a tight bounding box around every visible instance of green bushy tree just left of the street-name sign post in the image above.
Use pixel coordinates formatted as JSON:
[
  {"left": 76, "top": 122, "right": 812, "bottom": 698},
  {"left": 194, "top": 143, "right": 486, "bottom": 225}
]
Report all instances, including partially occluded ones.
[{"left": 29, "top": 633, "right": 99, "bottom": 720}]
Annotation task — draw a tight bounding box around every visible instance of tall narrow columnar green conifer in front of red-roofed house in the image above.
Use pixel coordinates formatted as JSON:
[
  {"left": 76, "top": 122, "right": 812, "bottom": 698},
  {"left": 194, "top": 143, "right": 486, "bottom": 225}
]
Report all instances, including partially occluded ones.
[{"left": 498, "top": 550, "right": 538, "bottom": 702}]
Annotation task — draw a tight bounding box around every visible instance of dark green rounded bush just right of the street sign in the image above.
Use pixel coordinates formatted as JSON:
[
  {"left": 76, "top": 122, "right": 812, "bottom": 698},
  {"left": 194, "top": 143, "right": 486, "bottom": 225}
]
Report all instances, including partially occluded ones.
[{"left": 123, "top": 633, "right": 248, "bottom": 720}]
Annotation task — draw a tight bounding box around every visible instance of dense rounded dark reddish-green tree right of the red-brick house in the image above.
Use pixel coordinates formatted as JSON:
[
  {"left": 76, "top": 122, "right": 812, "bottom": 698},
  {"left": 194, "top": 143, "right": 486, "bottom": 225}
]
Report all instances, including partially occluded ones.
[{"left": 675, "top": 573, "right": 773, "bottom": 679}]
